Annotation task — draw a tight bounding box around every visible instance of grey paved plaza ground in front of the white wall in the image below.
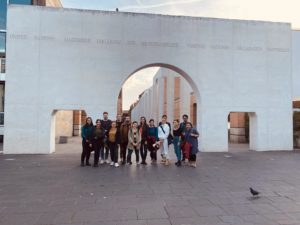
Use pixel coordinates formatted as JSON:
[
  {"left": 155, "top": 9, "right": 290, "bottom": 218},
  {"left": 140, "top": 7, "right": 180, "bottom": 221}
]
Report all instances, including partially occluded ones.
[{"left": 0, "top": 139, "right": 300, "bottom": 225}]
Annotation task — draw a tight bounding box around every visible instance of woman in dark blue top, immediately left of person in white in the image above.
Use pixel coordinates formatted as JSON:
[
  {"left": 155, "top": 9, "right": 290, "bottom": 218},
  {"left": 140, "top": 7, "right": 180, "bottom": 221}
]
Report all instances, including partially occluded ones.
[{"left": 147, "top": 119, "right": 159, "bottom": 164}]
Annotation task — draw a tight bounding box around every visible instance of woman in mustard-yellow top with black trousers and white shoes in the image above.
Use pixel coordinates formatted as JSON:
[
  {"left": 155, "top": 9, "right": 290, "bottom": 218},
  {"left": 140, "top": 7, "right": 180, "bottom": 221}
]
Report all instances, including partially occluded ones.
[{"left": 107, "top": 121, "right": 120, "bottom": 167}]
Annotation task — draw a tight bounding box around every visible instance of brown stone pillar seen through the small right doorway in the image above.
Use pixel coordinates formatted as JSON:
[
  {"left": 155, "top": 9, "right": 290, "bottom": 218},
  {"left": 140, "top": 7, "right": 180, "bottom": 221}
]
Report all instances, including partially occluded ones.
[{"left": 229, "top": 112, "right": 246, "bottom": 143}]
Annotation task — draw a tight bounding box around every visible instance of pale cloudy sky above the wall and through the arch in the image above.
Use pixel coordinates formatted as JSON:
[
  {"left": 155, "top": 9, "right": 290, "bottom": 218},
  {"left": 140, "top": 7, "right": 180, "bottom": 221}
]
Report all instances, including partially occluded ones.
[{"left": 61, "top": 0, "right": 300, "bottom": 109}]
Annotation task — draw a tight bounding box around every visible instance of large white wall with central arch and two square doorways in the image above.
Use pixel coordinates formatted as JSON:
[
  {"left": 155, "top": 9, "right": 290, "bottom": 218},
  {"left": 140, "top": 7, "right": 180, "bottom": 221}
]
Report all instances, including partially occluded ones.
[{"left": 4, "top": 5, "right": 293, "bottom": 154}]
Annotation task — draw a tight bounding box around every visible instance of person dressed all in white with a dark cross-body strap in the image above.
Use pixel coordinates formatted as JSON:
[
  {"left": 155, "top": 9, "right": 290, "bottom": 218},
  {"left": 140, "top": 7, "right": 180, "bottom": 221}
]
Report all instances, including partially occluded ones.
[{"left": 158, "top": 115, "right": 170, "bottom": 166}]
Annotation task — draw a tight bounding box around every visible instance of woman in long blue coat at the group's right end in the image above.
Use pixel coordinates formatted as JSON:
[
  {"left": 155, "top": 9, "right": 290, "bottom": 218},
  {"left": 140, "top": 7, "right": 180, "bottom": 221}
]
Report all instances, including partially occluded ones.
[{"left": 184, "top": 122, "right": 199, "bottom": 167}]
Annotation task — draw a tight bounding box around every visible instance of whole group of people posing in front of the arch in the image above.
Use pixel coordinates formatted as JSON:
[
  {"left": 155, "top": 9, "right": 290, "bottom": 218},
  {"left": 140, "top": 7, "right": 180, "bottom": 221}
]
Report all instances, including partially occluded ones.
[{"left": 81, "top": 112, "right": 199, "bottom": 167}]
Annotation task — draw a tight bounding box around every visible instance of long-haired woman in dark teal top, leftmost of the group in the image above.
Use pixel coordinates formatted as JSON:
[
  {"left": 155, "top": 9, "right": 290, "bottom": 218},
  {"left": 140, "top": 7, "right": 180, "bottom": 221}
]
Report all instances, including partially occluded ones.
[{"left": 81, "top": 117, "right": 93, "bottom": 166}]
